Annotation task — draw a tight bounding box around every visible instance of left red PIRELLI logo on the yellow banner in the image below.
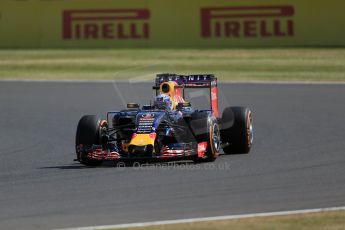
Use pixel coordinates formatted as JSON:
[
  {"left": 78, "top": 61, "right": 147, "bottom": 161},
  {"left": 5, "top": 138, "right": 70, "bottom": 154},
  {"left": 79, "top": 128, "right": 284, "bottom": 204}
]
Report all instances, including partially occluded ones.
[{"left": 63, "top": 9, "right": 150, "bottom": 40}]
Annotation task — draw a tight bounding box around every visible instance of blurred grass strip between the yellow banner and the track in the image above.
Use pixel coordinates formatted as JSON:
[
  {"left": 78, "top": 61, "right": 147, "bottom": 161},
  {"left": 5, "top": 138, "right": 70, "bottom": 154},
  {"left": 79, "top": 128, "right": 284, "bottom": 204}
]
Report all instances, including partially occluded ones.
[{"left": 0, "top": 48, "right": 345, "bottom": 81}]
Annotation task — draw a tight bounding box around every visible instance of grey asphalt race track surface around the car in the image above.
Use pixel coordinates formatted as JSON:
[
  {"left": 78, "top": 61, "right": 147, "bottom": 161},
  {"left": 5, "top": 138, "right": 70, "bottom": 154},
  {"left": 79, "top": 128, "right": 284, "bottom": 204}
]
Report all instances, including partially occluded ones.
[{"left": 0, "top": 82, "right": 345, "bottom": 229}]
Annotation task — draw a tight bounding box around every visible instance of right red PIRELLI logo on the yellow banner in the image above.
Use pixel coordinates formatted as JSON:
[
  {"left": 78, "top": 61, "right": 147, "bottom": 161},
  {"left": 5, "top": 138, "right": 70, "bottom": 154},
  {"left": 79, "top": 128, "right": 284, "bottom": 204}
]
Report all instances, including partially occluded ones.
[{"left": 201, "top": 6, "right": 295, "bottom": 38}]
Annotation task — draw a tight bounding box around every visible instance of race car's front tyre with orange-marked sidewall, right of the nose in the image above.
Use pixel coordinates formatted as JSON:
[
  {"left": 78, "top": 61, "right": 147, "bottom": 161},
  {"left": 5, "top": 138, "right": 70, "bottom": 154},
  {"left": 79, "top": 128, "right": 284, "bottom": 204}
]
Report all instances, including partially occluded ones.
[{"left": 190, "top": 112, "right": 220, "bottom": 162}]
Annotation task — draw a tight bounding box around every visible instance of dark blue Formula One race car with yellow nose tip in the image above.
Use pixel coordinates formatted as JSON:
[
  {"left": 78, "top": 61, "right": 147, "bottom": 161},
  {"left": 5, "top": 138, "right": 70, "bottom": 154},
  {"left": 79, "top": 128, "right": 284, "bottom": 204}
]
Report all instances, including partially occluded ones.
[{"left": 75, "top": 74, "right": 253, "bottom": 166}]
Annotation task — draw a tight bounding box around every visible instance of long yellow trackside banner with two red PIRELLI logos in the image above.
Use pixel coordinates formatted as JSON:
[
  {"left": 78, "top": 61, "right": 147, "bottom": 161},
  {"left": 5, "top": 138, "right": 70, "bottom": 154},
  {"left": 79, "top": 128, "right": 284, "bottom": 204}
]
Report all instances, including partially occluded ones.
[{"left": 0, "top": 0, "right": 345, "bottom": 48}]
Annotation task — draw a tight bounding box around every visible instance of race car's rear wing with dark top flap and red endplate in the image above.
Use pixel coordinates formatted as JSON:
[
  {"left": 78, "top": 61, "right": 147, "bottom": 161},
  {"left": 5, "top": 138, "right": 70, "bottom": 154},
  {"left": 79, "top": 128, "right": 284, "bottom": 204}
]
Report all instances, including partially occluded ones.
[{"left": 153, "top": 73, "right": 219, "bottom": 118}]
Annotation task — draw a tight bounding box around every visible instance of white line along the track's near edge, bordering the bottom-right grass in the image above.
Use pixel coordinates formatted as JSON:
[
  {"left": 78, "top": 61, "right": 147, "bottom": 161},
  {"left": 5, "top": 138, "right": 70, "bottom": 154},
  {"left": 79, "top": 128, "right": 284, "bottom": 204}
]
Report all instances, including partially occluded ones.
[{"left": 56, "top": 206, "right": 345, "bottom": 230}]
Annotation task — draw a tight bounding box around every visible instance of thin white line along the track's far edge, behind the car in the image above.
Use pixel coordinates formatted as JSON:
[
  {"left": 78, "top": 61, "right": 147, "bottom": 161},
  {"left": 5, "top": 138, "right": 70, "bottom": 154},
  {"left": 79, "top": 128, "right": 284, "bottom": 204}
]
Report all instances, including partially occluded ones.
[{"left": 0, "top": 79, "right": 345, "bottom": 85}]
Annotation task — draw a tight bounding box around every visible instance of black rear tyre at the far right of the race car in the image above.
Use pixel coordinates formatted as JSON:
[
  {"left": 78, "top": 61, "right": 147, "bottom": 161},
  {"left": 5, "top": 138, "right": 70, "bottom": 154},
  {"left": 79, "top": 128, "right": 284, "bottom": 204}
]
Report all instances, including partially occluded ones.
[{"left": 221, "top": 107, "right": 253, "bottom": 154}]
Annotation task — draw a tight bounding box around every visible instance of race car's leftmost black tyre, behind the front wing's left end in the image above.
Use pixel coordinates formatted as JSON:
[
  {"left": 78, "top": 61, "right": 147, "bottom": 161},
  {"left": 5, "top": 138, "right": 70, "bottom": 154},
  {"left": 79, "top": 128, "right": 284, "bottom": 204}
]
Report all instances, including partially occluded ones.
[{"left": 75, "top": 115, "right": 102, "bottom": 166}]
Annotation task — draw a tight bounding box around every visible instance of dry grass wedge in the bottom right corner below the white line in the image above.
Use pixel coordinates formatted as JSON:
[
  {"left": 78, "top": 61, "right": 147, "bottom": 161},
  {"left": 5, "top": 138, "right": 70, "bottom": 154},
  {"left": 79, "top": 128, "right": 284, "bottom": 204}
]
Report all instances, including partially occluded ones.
[{"left": 116, "top": 211, "right": 345, "bottom": 230}]
